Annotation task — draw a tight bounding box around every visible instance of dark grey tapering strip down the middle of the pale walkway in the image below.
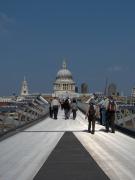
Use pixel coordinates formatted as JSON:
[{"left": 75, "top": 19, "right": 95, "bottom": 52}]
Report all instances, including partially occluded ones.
[{"left": 34, "top": 132, "right": 109, "bottom": 180}]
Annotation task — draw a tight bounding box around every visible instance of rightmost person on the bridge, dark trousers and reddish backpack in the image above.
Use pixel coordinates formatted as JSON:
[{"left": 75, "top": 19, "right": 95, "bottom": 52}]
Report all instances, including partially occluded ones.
[{"left": 106, "top": 96, "right": 116, "bottom": 133}]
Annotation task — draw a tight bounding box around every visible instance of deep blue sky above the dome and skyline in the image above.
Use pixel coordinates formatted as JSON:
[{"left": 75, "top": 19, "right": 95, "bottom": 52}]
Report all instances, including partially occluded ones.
[{"left": 0, "top": 0, "right": 135, "bottom": 96}]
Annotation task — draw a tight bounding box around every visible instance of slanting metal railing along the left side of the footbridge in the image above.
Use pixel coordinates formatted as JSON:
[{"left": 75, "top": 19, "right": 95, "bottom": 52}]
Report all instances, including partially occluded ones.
[{"left": 0, "top": 97, "right": 49, "bottom": 137}]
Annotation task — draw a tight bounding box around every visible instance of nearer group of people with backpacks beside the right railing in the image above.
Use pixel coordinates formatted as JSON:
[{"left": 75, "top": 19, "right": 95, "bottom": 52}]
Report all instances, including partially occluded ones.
[{"left": 85, "top": 96, "right": 117, "bottom": 134}]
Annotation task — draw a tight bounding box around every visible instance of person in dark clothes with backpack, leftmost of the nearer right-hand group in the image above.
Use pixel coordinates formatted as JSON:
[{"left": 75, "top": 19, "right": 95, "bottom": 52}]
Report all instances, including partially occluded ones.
[{"left": 85, "top": 99, "right": 96, "bottom": 134}]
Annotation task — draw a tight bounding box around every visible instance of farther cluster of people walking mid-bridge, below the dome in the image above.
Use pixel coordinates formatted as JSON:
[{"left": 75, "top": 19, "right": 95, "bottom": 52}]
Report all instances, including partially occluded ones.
[{"left": 49, "top": 97, "right": 78, "bottom": 120}]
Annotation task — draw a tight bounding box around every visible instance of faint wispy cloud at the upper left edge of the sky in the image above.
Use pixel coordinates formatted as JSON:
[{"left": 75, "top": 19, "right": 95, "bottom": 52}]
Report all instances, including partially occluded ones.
[{"left": 0, "top": 12, "right": 14, "bottom": 32}]
